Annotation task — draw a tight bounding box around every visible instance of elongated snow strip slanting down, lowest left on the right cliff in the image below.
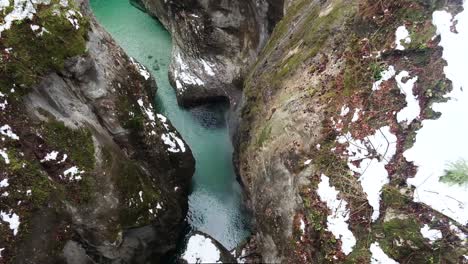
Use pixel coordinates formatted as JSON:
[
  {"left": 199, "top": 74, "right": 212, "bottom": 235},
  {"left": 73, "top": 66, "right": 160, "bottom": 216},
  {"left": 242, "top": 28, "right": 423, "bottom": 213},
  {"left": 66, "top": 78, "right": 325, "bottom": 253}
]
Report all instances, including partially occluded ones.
[{"left": 317, "top": 174, "right": 356, "bottom": 255}]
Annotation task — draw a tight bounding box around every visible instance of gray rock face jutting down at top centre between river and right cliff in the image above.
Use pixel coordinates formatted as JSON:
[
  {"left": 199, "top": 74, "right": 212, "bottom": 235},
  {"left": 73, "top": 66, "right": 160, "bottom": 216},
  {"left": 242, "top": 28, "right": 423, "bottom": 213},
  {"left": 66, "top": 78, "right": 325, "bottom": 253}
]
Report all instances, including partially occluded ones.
[{"left": 134, "top": 0, "right": 283, "bottom": 106}]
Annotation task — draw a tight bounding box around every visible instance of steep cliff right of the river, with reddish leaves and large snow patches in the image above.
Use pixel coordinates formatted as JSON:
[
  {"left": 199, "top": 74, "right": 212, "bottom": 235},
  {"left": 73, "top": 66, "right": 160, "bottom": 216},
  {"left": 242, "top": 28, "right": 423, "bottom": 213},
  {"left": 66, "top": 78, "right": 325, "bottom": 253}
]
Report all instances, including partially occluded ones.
[{"left": 237, "top": 0, "right": 468, "bottom": 263}]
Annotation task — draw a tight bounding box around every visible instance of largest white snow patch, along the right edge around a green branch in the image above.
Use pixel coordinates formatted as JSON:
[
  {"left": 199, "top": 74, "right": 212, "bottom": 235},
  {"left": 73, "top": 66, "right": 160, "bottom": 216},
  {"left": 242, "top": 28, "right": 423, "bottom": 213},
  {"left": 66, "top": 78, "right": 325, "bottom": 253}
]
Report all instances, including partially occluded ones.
[{"left": 404, "top": 1, "right": 468, "bottom": 225}]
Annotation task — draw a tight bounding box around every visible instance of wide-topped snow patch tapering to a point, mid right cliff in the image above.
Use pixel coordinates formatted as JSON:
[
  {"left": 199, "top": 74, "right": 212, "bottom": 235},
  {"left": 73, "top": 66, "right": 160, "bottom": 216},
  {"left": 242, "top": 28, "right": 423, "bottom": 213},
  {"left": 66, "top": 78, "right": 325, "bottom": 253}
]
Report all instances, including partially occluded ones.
[{"left": 338, "top": 126, "right": 397, "bottom": 221}]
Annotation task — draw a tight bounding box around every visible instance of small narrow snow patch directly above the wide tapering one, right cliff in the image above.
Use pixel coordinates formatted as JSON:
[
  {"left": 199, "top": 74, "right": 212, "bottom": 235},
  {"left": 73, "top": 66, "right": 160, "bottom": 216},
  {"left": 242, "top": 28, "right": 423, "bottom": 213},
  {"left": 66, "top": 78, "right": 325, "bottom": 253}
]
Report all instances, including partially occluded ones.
[{"left": 395, "top": 71, "right": 421, "bottom": 125}]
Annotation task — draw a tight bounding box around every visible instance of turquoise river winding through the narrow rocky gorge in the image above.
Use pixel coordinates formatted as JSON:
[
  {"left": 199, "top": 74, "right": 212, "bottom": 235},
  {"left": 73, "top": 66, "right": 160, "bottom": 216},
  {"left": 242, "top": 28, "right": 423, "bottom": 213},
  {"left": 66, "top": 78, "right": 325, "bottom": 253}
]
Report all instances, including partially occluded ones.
[{"left": 91, "top": 0, "right": 250, "bottom": 256}]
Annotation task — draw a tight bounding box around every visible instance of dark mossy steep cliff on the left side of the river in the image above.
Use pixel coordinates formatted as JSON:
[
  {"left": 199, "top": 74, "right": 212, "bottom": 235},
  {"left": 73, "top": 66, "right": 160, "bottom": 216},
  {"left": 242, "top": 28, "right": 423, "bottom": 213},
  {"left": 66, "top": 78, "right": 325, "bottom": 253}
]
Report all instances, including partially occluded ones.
[{"left": 0, "top": 0, "right": 194, "bottom": 263}]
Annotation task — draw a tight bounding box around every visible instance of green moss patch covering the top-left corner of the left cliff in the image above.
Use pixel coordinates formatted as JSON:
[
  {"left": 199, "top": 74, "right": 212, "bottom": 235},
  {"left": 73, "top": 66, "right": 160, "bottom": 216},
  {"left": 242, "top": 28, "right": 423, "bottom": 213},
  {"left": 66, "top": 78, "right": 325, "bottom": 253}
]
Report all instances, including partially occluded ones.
[{"left": 0, "top": 0, "right": 89, "bottom": 96}]
